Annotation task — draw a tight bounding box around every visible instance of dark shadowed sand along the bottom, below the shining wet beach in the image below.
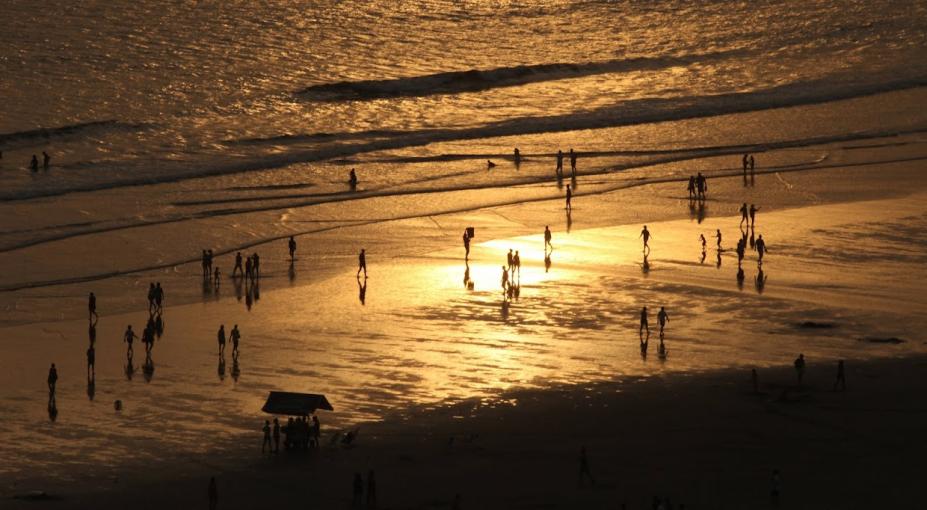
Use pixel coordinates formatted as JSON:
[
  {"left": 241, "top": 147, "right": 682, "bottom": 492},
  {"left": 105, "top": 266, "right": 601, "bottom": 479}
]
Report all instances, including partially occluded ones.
[{"left": 9, "top": 357, "right": 927, "bottom": 509}]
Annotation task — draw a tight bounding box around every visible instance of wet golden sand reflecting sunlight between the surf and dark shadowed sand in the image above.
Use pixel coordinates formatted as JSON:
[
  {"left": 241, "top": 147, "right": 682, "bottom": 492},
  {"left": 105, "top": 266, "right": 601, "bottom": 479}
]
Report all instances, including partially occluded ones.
[{"left": 0, "top": 131, "right": 925, "bottom": 508}]
